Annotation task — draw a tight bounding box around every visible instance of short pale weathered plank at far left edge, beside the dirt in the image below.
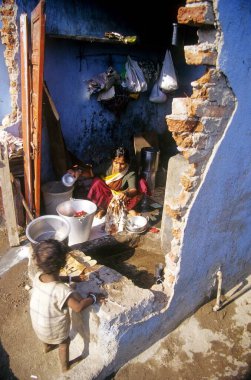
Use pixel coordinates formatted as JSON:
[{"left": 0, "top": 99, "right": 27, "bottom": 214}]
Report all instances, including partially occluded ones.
[{"left": 0, "top": 144, "right": 20, "bottom": 247}]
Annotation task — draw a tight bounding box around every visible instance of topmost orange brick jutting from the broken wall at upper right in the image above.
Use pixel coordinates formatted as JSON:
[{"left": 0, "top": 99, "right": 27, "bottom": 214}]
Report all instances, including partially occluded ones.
[{"left": 177, "top": 3, "right": 215, "bottom": 26}]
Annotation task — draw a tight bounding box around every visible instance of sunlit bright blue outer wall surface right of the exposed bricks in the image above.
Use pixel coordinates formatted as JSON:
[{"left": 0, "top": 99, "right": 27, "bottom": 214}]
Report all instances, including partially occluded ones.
[{"left": 170, "top": 0, "right": 251, "bottom": 316}]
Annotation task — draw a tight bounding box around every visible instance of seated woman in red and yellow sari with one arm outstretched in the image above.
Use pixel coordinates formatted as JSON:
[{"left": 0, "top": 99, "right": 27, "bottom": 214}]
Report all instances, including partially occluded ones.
[{"left": 68, "top": 146, "right": 148, "bottom": 218}]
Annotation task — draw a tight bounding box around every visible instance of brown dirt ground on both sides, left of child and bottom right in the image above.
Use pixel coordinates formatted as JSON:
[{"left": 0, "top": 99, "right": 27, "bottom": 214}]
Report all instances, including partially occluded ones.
[{"left": 0, "top": 229, "right": 251, "bottom": 380}]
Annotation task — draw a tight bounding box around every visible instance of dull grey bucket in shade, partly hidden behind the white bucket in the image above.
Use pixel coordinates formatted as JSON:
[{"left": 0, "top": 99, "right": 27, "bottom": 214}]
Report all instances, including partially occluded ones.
[{"left": 42, "top": 181, "right": 74, "bottom": 215}]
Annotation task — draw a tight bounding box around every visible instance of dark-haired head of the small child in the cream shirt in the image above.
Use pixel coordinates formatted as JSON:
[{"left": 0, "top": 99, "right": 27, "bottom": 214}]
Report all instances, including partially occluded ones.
[{"left": 34, "top": 239, "right": 68, "bottom": 274}]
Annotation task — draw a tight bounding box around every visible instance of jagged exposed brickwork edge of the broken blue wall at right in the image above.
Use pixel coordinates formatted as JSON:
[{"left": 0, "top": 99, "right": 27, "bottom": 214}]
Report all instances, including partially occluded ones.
[{"left": 164, "top": 0, "right": 235, "bottom": 287}]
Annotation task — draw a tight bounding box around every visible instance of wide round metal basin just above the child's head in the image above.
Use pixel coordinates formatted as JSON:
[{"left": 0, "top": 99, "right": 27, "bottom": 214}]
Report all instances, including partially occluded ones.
[{"left": 26, "top": 215, "right": 71, "bottom": 245}]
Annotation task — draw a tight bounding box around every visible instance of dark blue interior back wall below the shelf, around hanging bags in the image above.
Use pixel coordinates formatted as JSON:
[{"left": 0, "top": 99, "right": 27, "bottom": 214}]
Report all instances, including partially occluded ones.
[{"left": 45, "top": 39, "right": 170, "bottom": 161}]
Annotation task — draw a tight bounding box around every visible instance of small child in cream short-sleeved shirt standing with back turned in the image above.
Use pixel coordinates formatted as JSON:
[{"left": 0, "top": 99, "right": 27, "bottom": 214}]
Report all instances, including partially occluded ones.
[{"left": 30, "top": 239, "right": 105, "bottom": 372}]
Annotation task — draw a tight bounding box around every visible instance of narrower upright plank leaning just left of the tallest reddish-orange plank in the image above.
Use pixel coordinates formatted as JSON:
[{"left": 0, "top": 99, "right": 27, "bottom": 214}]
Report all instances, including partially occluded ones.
[{"left": 20, "top": 14, "right": 34, "bottom": 215}]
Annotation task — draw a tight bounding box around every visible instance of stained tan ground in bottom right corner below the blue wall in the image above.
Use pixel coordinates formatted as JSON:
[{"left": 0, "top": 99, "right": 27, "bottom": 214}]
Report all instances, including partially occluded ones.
[{"left": 113, "top": 275, "right": 251, "bottom": 380}]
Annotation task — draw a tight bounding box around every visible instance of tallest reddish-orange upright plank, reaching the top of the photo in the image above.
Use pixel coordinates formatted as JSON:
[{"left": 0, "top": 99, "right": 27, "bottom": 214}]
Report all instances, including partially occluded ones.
[{"left": 31, "top": 0, "right": 45, "bottom": 216}]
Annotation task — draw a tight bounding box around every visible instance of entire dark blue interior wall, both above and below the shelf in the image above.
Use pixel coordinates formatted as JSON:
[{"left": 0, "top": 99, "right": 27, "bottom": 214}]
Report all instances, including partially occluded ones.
[{"left": 13, "top": 0, "right": 202, "bottom": 181}]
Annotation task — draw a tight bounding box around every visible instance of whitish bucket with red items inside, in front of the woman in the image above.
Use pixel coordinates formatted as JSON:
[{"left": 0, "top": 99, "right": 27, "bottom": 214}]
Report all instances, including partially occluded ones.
[{"left": 56, "top": 199, "right": 97, "bottom": 246}]
